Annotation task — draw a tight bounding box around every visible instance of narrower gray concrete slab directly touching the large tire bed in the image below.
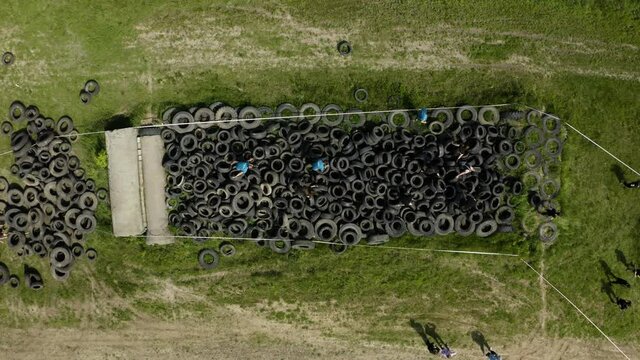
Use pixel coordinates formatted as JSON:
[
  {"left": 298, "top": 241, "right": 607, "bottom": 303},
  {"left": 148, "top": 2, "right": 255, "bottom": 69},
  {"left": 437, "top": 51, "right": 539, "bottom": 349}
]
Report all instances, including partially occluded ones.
[{"left": 140, "top": 135, "right": 175, "bottom": 245}]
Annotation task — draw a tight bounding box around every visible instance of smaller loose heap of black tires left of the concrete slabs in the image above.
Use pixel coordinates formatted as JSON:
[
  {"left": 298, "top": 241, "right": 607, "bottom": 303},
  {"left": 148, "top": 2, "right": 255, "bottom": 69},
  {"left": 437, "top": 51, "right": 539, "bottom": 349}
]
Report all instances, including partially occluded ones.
[{"left": 0, "top": 101, "right": 108, "bottom": 281}]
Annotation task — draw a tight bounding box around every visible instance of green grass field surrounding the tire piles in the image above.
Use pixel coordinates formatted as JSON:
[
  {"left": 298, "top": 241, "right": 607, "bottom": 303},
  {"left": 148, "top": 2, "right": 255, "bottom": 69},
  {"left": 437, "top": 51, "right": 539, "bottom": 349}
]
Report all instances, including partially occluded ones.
[{"left": 0, "top": 0, "right": 640, "bottom": 358}]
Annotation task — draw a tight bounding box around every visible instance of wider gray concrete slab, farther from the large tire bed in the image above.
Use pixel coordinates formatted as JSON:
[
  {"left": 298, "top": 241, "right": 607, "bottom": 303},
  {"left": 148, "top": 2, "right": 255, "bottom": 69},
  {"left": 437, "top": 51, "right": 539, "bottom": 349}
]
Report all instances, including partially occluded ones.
[{"left": 105, "top": 129, "right": 144, "bottom": 236}]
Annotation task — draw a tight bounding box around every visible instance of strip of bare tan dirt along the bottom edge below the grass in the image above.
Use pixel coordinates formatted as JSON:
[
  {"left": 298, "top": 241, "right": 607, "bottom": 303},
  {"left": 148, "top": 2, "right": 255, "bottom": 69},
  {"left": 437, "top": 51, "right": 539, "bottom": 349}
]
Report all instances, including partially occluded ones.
[{"left": 0, "top": 306, "right": 638, "bottom": 360}]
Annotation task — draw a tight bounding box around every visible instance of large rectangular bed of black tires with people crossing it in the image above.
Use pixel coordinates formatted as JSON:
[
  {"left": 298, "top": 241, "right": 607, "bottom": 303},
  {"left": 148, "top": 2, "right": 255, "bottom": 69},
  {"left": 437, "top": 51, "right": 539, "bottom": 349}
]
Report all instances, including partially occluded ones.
[{"left": 161, "top": 102, "right": 522, "bottom": 253}]
